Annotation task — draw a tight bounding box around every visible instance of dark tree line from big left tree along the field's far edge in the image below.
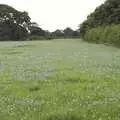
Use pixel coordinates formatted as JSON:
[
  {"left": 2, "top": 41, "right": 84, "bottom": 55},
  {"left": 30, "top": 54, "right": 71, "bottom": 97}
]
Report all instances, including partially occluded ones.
[{"left": 0, "top": 4, "right": 79, "bottom": 40}]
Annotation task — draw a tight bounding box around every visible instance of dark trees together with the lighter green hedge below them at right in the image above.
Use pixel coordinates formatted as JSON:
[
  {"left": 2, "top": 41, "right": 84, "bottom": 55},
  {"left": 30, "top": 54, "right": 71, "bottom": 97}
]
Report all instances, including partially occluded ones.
[{"left": 80, "top": 0, "right": 120, "bottom": 47}]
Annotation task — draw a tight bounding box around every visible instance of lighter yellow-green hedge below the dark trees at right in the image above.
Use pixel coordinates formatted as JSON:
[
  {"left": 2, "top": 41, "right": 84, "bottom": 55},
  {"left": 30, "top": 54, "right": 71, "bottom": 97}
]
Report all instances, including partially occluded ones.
[{"left": 84, "top": 25, "right": 120, "bottom": 46}]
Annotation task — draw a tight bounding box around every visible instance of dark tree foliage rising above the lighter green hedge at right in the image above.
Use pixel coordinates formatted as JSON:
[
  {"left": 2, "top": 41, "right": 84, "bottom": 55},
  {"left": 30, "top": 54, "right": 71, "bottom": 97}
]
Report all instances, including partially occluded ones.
[{"left": 80, "top": 0, "right": 120, "bottom": 36}]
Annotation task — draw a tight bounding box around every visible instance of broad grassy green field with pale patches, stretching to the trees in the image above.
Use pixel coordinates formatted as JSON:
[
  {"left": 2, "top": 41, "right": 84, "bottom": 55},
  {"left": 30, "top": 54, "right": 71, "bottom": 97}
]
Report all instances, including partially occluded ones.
[{"left": 0, "top": 39, "right": 120, "bottom": 120}]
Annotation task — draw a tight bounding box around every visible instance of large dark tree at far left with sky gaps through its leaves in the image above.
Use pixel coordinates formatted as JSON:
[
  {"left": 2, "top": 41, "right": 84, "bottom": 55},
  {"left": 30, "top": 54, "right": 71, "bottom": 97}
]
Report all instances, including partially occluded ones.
[{"left": 0, "top": 4, "right": 30, "bottom": 40}]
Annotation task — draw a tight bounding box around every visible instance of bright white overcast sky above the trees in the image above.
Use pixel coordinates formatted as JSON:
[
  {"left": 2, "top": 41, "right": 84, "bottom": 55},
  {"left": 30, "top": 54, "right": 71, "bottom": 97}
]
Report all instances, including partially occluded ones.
[{"left": 0, "top": 0, "right": 105, "bottom": 32}]
